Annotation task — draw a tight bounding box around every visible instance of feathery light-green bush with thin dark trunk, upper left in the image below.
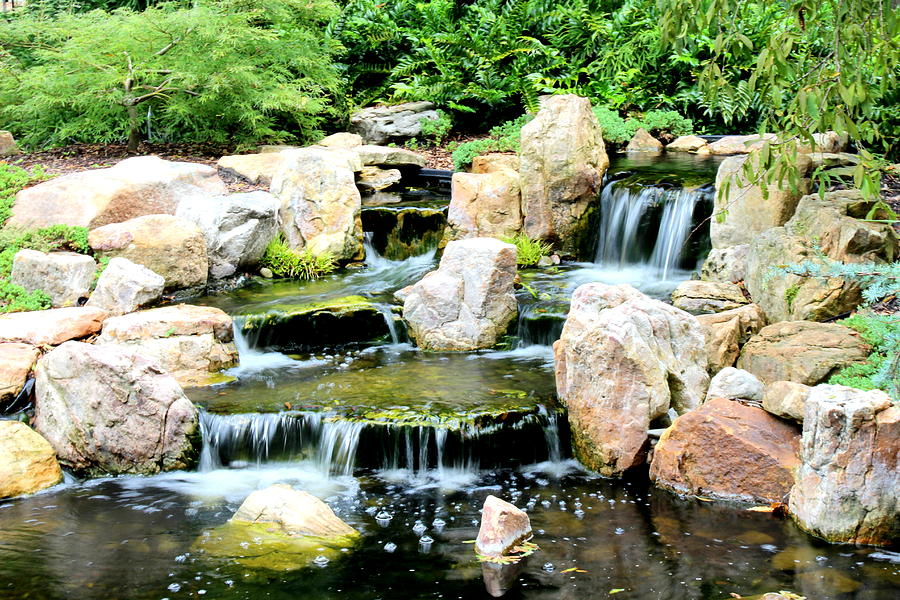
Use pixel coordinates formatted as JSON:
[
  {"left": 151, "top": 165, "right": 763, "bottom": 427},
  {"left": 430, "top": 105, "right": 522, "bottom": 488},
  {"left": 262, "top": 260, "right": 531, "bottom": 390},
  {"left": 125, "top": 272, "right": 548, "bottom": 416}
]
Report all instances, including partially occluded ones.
[{"left": 0, "top": 0, "right": 340, "bottom": 148}]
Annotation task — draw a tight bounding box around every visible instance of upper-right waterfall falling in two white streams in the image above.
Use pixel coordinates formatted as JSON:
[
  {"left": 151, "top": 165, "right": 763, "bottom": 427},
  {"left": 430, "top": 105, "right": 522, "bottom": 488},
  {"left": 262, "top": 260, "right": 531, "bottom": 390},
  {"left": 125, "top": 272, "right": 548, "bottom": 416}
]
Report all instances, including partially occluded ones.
[{"left": 595, "top": 180, "right": 711, "bottom": 278}]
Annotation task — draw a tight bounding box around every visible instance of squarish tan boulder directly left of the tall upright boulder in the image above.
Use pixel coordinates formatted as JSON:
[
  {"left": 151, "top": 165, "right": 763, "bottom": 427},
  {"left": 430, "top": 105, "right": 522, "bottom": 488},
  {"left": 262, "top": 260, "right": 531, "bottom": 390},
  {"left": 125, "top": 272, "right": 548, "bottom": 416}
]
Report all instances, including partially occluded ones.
[{"left": 446, "top": 169, "right": 522, "bottom": 240}]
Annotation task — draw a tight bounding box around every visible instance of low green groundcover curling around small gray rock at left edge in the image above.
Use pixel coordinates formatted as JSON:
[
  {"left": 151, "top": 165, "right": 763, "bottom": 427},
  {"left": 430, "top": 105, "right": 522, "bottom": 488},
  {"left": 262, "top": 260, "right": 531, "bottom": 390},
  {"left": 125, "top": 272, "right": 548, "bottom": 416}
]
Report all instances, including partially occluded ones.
[{"left": 0, "top": 225, "right": 90, "bottom": 313}]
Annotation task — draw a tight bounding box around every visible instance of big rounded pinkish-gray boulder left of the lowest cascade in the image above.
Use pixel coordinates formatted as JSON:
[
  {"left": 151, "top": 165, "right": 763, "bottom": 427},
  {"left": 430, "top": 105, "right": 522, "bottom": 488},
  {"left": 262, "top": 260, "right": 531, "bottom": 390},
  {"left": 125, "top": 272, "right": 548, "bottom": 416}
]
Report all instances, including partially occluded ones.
[{"left": 34, "top": 342, "right": 200, "bottom": 475}]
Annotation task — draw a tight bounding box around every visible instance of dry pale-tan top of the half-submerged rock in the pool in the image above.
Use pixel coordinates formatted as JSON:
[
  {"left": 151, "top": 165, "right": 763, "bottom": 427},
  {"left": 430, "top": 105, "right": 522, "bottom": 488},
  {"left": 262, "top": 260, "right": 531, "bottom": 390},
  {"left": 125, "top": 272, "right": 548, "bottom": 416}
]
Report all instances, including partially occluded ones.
[{"left": 231, "top": 483, "right": 358, "bottom": 538}]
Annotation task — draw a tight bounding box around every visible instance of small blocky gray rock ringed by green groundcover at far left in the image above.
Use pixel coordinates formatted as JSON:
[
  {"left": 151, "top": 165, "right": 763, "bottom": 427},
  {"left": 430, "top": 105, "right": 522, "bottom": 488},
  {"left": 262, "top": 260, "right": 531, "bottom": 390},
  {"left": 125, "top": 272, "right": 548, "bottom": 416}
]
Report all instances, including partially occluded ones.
[{"left": 11, "top": 250, "right": 97, "bottom": 308}]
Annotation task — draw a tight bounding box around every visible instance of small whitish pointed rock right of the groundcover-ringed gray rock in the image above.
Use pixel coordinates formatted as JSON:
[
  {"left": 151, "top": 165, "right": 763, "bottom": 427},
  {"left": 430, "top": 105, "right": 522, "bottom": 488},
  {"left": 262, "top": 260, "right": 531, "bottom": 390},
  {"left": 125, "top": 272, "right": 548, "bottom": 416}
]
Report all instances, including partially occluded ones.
[{"left": 85, "top": 256, "right": 166, "bottom": 317}]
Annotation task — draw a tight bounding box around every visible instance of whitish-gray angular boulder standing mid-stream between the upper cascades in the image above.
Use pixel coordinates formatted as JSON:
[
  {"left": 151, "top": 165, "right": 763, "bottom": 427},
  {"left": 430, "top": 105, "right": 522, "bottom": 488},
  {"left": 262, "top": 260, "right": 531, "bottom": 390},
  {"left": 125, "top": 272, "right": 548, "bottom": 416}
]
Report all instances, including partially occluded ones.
[{"left": 403, "top": 238, "right": 518, "bottom": 351}]
